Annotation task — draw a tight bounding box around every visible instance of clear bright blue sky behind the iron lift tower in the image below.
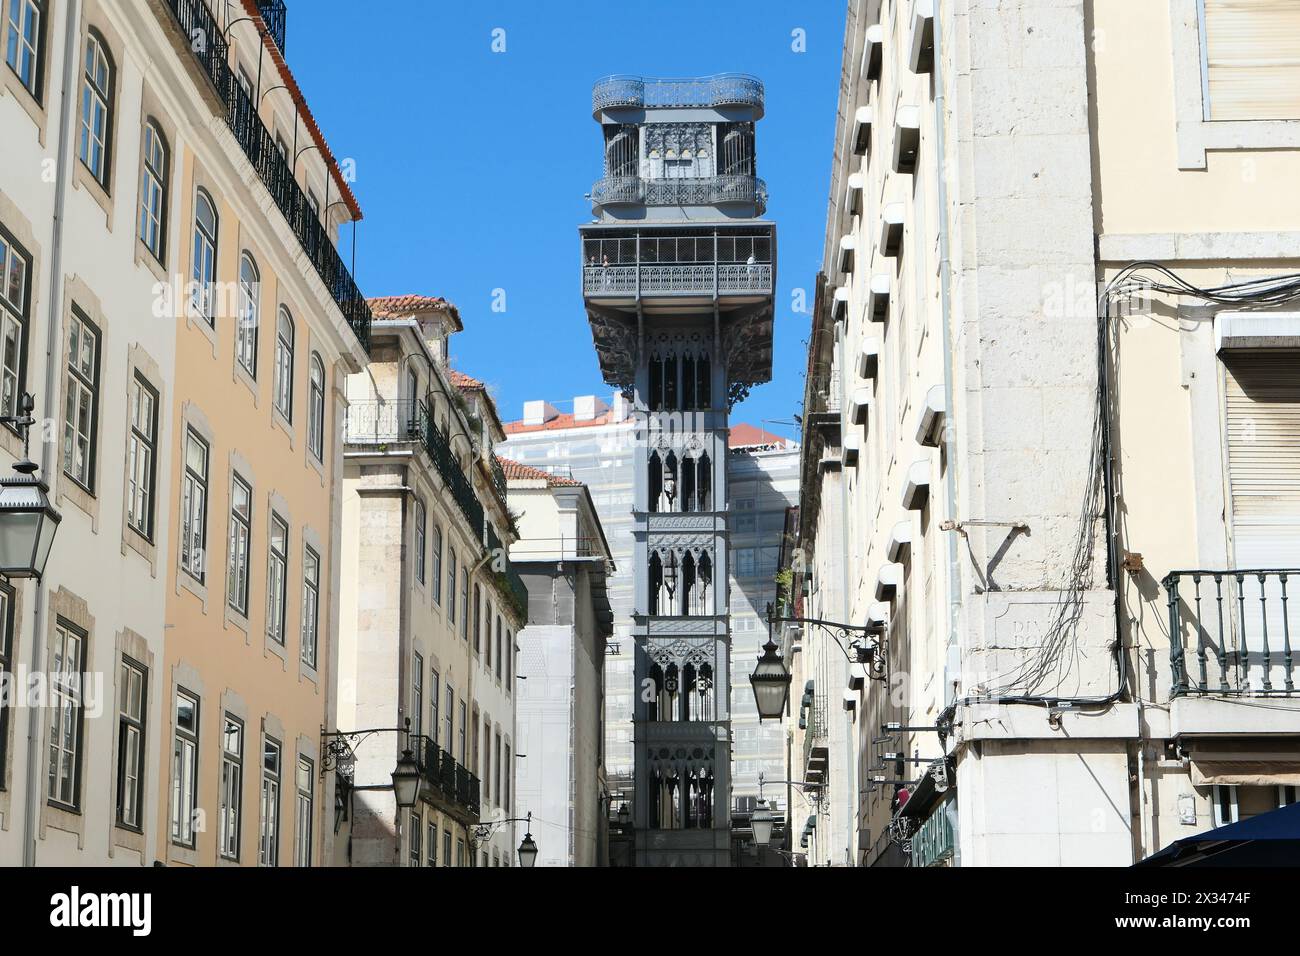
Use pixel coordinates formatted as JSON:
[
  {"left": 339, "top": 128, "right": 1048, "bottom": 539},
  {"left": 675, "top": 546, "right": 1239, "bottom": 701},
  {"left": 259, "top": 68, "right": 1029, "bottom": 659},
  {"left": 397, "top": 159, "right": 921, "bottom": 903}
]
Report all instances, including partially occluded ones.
[{"left": 286, "top": 0, "right": 845, "bottom": 434}]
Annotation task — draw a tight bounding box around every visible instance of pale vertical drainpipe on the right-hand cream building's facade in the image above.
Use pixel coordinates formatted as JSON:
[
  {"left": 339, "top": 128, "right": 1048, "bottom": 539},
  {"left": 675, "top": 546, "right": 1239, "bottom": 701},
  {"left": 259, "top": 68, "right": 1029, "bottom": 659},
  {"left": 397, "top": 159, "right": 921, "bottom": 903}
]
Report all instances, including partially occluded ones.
[{"left": 935, "top": 3, "right": 962, "bottom": 705}]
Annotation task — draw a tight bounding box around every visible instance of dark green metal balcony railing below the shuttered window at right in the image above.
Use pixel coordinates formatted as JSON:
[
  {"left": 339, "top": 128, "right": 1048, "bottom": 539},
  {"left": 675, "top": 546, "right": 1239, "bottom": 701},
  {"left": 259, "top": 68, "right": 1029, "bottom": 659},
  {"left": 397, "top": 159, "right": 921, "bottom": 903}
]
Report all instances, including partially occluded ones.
[{"left": 1162, "top": 568, "right": 1300, "bottom": 697}]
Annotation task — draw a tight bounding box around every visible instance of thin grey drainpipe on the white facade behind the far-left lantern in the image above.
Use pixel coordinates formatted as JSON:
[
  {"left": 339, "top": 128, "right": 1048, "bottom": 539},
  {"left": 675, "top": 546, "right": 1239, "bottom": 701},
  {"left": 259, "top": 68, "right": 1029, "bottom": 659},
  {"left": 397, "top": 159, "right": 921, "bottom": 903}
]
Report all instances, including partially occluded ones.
[{"left": 22, "top": 0, "right": 81, "bottom": 866}]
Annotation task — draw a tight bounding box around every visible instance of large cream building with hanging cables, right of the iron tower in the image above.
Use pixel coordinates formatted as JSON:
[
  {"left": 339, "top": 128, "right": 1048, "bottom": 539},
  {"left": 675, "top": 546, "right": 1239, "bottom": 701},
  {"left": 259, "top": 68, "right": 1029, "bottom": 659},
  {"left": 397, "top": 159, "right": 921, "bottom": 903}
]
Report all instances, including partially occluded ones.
[{"left": 794, "top": 0, "right": 1300, "bottom": 866}]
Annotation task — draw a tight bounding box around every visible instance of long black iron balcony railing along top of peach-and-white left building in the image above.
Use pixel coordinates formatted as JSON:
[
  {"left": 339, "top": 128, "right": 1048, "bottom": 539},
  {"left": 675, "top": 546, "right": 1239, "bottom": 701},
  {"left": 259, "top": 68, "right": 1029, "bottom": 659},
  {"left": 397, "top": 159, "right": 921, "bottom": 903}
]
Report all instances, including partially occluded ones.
[{"left": 165, "top": 0, "right": 371, "bottom": 352}]
